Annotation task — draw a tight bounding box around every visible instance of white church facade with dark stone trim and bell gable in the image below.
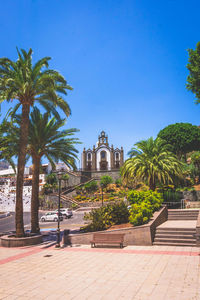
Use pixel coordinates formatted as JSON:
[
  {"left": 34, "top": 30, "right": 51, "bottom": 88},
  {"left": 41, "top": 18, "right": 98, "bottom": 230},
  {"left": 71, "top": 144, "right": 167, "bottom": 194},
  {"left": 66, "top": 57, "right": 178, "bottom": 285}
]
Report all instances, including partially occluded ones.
[{"left": 82, "top": 131, "right": 124, "bottom": 172}]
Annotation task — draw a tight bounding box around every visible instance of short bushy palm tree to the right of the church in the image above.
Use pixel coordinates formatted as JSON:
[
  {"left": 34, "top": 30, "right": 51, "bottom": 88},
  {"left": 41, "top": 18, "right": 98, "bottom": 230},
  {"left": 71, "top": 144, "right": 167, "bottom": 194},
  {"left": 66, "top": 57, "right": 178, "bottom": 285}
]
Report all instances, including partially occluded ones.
[{"left": 121, "top": 137, "right": 182, "bottom": 191}]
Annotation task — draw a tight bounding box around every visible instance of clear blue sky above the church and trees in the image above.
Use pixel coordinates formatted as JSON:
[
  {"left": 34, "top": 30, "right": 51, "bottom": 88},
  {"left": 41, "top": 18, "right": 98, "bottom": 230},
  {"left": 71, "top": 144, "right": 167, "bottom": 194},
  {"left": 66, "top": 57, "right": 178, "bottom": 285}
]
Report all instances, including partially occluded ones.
[{"left": 0, "top": 0, "right": 200, "bottom": 164}]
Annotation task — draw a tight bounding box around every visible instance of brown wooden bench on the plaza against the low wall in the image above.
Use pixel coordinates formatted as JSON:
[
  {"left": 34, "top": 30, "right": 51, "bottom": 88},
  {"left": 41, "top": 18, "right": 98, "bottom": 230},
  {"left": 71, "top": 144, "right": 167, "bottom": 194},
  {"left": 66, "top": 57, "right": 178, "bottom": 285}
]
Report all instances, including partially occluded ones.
[{"left": 90, "top": 233, "right": 124, "bottom": 248}]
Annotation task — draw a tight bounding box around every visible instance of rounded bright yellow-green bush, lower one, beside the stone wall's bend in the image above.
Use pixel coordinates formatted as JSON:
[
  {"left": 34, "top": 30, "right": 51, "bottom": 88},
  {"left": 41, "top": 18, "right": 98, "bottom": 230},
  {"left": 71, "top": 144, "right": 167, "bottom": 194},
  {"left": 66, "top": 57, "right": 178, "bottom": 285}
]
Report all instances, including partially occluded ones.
[{"left": 129, "top": 202, "right": 153, "bottom": 226}]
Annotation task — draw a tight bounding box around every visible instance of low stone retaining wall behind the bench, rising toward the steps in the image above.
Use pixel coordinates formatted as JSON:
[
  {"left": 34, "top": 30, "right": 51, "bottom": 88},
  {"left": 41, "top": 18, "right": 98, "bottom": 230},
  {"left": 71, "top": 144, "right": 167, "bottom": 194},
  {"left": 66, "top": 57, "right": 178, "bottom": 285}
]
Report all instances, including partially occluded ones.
[{"left": 69, "top": 207, "right": 167, "bottom": 246}]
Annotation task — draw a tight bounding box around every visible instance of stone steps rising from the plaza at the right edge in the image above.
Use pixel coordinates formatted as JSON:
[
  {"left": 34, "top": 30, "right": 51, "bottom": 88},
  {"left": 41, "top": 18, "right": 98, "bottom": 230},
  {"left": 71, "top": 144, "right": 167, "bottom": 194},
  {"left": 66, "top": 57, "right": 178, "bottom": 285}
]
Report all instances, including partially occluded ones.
[{"left": 153, "top": 209, "right": 199, "bottom": 247}]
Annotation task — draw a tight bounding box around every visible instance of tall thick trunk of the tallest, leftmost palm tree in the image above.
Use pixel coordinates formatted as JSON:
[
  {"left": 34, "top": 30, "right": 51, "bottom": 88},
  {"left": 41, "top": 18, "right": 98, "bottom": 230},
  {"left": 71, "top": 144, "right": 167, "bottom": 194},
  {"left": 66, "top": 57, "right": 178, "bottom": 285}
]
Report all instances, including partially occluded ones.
[{"left": 15, "top": 104, "right": 30, "bottom": 237}]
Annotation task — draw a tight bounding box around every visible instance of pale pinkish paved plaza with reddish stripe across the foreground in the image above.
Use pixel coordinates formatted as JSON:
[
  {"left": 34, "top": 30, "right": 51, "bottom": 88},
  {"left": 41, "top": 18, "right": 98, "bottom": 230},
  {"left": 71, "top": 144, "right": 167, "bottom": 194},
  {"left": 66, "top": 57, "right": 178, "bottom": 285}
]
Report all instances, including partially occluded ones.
[{"left": 0, "top": 245, "right": 200, "bottom": 300}]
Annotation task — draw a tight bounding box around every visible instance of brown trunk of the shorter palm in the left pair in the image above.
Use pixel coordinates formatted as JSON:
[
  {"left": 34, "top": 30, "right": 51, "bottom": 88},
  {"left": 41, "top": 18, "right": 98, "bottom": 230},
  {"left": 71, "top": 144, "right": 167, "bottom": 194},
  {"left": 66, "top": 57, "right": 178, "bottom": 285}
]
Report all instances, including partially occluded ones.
[{"left": 31, "top": 156, "right": 40, "bottom": 233}]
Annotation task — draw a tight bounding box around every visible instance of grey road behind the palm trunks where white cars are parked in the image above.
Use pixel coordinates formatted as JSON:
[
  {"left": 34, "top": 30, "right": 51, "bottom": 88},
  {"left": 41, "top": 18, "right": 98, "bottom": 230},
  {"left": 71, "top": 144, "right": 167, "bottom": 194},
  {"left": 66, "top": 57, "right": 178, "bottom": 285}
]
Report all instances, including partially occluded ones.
[{"left": 0, "top": 212, "right": 84, "bottom": 234}]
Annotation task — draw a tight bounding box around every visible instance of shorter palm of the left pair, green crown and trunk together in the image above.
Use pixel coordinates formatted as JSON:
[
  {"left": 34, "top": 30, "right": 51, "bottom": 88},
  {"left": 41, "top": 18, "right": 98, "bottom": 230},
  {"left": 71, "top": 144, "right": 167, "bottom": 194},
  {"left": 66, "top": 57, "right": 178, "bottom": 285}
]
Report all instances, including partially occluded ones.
[{"left": 27, "top": 107, "right": 79, "bottom": 233}]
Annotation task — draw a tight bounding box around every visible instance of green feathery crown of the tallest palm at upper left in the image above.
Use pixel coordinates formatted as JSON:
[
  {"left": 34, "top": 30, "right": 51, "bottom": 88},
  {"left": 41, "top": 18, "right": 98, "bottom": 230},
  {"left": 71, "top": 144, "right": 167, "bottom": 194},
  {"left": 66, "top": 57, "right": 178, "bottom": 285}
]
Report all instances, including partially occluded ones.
[{"left": 0, "top": 49, "right": 72, "bottom": 116}]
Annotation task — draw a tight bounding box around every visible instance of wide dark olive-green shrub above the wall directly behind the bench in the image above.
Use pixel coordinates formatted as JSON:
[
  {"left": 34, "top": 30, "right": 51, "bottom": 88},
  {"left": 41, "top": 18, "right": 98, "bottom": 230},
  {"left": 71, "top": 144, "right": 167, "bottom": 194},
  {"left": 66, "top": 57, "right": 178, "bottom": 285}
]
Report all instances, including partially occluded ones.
[{"left": 82, "top": 202, "right": 129, "bottom": 232}]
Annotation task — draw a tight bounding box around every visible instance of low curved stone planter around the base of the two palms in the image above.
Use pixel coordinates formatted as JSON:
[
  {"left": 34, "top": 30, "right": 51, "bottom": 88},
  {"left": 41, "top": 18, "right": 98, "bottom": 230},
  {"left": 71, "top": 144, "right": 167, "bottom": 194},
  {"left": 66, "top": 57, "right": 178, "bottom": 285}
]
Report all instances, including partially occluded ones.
[{"left": 1, "top": 234, "right": 42, "bottom": 247}]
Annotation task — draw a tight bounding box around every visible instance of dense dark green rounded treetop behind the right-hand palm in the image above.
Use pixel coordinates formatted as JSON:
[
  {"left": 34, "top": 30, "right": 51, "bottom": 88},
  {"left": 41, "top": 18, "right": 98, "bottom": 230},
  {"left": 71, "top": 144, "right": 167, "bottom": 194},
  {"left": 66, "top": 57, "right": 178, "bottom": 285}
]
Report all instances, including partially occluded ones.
[{"left": 158, "top": 123, "right": 200, "bottom": 159}]
